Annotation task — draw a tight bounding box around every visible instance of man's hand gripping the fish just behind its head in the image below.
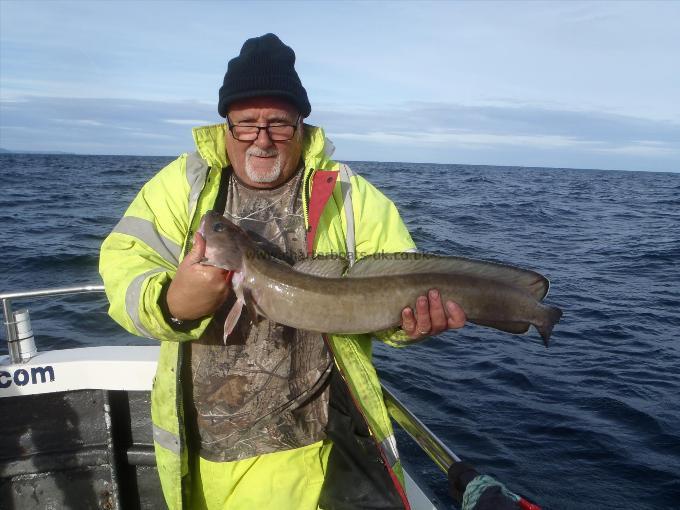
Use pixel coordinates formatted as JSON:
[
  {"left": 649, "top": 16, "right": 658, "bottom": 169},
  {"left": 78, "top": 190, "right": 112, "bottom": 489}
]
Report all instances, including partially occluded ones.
[{"left": 167, "top": 233, "right": 231, "bottom": 320}]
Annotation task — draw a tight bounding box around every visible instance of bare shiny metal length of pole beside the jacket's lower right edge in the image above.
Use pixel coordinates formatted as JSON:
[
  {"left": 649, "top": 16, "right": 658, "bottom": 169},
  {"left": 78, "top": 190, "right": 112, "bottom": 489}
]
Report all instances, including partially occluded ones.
[{"left": 382, "top": 385, "right": 461, "bottom": 473}]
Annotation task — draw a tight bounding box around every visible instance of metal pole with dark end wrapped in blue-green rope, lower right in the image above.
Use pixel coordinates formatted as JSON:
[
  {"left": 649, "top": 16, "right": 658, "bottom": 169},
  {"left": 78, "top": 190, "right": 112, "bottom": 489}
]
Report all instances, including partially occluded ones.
[{"left": 382, "top": 384, "right": 541, "bottom": 510}]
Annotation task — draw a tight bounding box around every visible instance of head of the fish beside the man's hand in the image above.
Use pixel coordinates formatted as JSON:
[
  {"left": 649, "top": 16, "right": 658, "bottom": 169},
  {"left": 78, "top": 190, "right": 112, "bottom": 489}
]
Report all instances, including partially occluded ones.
[{"left": 198, "top": 211, "right": 255, "bottom": 271}]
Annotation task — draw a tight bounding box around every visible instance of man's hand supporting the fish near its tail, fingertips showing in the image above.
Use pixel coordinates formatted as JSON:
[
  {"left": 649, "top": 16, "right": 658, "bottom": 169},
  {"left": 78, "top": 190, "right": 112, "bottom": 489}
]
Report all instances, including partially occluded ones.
[{"left": 401, "top": 289, "right": 466, "bottom": 340}]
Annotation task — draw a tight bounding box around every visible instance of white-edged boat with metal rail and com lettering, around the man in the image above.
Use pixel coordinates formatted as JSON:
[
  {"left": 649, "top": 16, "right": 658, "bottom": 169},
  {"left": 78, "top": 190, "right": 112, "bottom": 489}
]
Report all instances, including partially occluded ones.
[{"left": 0, "top": 285, "right": 537, "bottom": 510}]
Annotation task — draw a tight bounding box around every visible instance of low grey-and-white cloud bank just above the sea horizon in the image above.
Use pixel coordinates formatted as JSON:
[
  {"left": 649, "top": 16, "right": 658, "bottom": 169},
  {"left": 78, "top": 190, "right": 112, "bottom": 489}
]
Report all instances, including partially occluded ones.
[{"left": 0, "top": 96, "right": 680, "bottom": 171}]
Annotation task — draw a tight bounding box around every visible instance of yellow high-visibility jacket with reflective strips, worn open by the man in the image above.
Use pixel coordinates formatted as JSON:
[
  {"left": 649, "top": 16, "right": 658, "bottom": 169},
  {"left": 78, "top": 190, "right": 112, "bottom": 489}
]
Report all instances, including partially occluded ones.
[{"left": 99, "top": 124, "right": 415, "bottom": 509}]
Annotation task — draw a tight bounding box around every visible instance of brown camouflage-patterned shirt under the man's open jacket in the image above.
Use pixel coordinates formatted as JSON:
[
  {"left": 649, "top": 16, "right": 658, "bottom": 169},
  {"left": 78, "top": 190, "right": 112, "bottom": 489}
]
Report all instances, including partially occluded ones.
[{"left": 189, "top": 167, "right": 332, "bottom": 462}]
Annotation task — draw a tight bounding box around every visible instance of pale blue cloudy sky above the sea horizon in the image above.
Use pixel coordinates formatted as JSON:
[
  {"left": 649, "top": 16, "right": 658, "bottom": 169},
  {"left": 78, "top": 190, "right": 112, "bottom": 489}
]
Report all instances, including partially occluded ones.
[{"left": 0, "top": 0, "right": 680, "bottom": 172}]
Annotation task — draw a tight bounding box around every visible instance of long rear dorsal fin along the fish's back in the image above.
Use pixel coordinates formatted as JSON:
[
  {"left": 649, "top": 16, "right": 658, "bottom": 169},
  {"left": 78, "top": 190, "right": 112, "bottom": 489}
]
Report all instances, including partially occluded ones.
[{"left": 346, "top": 252, "right": 550, "bottom": 301}]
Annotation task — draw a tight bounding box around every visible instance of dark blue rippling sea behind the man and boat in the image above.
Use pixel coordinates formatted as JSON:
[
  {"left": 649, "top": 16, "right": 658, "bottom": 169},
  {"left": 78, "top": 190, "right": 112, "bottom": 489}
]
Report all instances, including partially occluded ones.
[{"left": 0, "top": 154, "right": 680, "bottom": 509}]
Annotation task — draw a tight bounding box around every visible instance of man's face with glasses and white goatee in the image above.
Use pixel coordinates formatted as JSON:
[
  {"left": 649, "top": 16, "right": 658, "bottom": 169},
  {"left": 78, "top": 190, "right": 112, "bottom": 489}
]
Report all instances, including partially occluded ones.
[{"left": 226, "top": 97, "right": 302, "bottom": 188}]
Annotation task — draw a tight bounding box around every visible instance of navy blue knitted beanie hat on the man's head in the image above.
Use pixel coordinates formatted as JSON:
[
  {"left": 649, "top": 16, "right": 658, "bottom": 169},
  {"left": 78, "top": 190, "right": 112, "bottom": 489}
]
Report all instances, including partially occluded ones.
[{"left": 217, "top": 34, "right": 312, "bottom": 117}]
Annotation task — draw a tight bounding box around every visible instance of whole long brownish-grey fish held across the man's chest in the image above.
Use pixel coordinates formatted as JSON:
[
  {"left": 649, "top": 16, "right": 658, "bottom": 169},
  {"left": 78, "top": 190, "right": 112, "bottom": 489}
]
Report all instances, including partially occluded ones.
[{"left": 199, "top": 211, "right": 562, "bottom": 347}]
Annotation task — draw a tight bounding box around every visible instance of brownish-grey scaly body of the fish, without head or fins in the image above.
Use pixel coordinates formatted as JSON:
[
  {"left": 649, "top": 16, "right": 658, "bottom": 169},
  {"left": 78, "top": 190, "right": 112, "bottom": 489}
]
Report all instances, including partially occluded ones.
[{"left": 245, "top": 259, "right": 542, "bottom": 334}]
